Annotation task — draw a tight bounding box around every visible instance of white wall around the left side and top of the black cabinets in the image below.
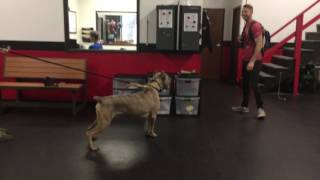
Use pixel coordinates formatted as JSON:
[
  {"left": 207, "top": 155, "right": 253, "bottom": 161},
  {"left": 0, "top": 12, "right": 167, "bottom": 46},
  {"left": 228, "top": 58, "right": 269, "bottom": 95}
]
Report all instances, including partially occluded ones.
[{"left": 140, "top": 0, "right": 203, "bottom": 44}]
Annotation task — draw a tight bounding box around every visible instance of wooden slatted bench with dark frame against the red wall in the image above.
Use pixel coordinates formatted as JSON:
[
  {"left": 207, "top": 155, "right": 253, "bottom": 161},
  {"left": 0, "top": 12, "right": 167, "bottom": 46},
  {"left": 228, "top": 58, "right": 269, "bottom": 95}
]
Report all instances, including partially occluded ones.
[{"left": 0, "top": 56, "right": 87, "bottom": 115}]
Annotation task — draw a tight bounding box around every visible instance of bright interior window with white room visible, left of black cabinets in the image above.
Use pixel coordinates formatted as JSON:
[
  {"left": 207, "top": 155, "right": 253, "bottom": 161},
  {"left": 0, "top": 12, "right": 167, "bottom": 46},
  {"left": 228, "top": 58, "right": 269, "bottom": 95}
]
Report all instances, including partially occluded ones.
[{"left": 69, "top": 0, "right": 138, "bottom": 51}]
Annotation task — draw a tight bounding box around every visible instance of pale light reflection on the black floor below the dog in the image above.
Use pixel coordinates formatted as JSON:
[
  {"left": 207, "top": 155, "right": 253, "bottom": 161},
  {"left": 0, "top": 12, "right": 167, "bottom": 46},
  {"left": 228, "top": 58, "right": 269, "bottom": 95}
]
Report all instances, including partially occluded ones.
[{"left": 85, "top": 137, "right": 152, "bottom": 179}]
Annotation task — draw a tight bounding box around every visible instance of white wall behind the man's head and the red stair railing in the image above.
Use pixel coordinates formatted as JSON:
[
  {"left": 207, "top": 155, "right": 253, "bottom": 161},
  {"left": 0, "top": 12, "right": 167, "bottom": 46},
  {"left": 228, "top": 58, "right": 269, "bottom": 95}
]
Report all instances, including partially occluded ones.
[{"left": 241, "top": 0, "right": 320, "bottom": 42}]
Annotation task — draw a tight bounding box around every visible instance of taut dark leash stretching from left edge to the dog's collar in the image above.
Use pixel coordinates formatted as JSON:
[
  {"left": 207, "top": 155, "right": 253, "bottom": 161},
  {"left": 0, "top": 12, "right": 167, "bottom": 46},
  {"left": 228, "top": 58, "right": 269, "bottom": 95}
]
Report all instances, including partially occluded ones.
[{"left": 0, "top": 46, "right": 132, "bottom": 84}]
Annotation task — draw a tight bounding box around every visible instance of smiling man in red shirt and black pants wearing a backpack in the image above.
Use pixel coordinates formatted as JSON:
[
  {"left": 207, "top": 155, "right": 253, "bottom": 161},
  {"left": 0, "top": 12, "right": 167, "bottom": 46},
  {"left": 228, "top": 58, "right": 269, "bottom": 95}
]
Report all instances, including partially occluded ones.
[{"left": 232, "top": 4, "right": 266, "bottom": 119}]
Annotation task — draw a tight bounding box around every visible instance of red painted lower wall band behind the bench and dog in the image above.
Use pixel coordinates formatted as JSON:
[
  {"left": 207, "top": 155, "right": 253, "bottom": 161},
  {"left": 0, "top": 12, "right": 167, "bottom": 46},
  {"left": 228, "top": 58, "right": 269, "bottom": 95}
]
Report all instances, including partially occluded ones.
[{"left": 0, "top": 51, "right": 201, "bottom": 100}]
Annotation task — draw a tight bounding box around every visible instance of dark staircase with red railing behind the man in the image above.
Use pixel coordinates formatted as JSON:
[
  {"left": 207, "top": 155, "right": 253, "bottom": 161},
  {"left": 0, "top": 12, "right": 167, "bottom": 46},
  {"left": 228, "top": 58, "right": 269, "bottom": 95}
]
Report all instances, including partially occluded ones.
[{"left": 259, "top": 0, "right": 320, "bottom": 96}]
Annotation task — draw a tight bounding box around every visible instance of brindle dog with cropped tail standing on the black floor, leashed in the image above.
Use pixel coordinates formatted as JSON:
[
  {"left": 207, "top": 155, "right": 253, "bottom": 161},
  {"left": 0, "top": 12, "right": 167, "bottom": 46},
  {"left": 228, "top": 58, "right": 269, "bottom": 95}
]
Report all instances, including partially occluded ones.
[{"left": 86, "top": 72, "right": 171, "bottom": 151}]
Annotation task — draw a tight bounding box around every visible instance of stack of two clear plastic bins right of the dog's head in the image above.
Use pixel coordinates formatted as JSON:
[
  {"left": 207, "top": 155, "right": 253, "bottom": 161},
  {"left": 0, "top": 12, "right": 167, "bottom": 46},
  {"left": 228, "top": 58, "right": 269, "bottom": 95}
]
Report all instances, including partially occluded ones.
[{"left": 175, "top": 74, "right": 200, "bottom": 115}]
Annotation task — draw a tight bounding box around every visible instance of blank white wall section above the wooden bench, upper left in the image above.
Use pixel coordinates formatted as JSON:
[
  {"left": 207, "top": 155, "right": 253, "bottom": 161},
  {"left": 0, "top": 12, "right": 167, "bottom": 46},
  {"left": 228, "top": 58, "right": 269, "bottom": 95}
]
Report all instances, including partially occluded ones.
[{"left": 0, "top": 0, "right": 65, "bottom": 42}]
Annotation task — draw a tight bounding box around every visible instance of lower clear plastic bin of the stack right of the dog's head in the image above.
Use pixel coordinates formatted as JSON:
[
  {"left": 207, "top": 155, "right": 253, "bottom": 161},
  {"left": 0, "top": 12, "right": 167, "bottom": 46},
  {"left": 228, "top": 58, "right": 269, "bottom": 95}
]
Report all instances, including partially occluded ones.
[{"left": 175, "top": 97, "right": 200, "bottom": 115}]
